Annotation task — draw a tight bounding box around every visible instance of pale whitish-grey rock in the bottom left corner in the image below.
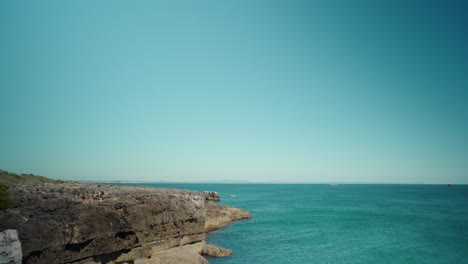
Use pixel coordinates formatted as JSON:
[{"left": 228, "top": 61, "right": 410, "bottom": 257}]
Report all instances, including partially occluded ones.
[{"left": 0, "top": 229, "right": 22, "bottom": 264}]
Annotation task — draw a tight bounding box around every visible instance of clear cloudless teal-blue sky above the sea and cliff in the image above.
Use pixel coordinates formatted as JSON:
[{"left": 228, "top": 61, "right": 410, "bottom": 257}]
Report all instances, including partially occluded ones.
[{"left": 0, "top": 0, "right": 468, "bottom": 183}]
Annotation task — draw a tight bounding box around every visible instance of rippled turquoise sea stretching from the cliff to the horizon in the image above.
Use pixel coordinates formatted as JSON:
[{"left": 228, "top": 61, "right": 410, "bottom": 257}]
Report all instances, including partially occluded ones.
[{"left": 121, "top": 184, "right": 468, "bottom": 264}]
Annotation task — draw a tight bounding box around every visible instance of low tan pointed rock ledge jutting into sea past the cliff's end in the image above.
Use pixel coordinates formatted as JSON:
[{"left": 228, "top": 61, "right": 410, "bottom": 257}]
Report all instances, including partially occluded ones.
[{"left": 205, "top": 204, "right": 252, "bottom": 232}]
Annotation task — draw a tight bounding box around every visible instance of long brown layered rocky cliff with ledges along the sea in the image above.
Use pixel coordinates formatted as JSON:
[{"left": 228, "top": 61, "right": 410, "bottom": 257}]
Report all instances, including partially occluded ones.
[{"left": 0, "top": 183, "right": 250, "bottom": 264}]
